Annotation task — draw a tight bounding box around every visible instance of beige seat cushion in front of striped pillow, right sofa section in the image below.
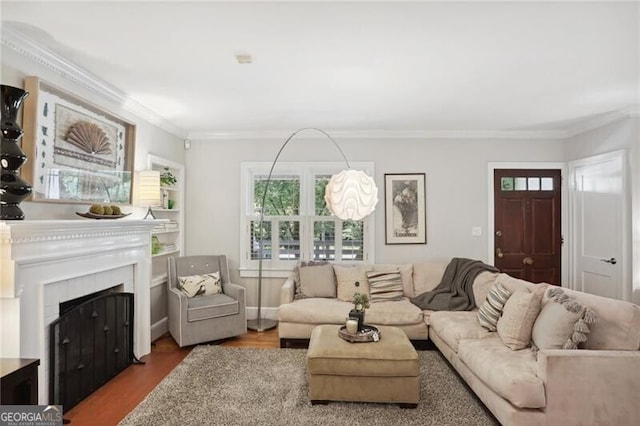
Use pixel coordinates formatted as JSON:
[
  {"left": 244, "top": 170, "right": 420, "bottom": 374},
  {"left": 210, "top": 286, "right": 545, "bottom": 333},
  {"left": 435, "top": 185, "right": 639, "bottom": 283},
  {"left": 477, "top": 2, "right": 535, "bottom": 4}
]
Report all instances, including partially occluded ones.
[{"left": 429, "top": 311, "right": 496, "bottom": 352}]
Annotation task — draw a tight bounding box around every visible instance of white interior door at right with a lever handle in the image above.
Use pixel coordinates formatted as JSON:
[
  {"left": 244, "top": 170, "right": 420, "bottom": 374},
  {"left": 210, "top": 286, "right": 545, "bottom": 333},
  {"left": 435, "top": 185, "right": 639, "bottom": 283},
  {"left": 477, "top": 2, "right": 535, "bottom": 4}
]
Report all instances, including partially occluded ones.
[{"left": 569, "top": 151, "right": 630, "bottom": 300}]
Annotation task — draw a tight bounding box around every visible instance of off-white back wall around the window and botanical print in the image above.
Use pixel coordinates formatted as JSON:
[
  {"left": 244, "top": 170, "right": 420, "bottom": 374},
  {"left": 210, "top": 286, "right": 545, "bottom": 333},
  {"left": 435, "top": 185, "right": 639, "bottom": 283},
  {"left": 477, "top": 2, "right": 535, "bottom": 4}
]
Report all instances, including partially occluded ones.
[{"left": 186, "top": 134, "right": 564, "bottom": 307}]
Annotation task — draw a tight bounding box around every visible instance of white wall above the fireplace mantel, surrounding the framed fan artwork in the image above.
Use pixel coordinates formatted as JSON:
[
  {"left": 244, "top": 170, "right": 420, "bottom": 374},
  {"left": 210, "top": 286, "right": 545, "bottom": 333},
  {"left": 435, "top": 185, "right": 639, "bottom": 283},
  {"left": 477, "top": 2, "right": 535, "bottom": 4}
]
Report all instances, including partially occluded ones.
[{"left": 0, "top": 47, "right": 185, "bottom": 220}]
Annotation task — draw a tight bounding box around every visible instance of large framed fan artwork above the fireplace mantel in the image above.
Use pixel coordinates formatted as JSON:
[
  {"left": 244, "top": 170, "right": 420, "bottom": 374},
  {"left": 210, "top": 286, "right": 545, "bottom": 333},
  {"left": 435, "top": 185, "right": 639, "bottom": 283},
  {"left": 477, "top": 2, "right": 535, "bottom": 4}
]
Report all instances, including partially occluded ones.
[{"left": 22, "top": 76, "right": 136, "bottom": 204}]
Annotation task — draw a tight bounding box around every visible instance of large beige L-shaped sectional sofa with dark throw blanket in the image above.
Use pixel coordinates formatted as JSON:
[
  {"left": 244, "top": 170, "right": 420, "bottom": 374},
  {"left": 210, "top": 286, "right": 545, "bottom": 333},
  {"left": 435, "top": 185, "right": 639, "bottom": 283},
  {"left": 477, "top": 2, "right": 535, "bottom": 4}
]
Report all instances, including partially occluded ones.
[{"left": 279, "top": 262, "right": 640, "bottom": 425}]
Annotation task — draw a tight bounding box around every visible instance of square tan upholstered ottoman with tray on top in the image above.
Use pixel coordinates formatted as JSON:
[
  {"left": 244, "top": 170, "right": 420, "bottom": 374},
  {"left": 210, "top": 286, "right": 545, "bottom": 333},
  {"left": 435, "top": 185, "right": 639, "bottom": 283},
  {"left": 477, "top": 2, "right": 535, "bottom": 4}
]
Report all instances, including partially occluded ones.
[{"left": 307, "top": 325, "right": 420, "bottom": 408}]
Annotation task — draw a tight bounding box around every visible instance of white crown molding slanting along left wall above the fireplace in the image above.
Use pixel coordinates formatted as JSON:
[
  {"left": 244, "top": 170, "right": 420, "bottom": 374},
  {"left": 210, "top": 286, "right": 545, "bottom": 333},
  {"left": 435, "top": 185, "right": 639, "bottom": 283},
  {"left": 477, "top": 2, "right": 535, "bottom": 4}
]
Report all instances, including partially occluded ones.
[{"left": 1, "top": 24, "right": 187, "bottom": 139}]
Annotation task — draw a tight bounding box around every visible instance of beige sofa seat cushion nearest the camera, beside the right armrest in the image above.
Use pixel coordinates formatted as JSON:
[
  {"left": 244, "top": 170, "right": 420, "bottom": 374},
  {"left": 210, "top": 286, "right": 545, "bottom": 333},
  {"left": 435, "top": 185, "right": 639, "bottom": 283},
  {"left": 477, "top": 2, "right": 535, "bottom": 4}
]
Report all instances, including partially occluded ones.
[{"left": 458, "top": 338, "right": 546, "bottom": 408}]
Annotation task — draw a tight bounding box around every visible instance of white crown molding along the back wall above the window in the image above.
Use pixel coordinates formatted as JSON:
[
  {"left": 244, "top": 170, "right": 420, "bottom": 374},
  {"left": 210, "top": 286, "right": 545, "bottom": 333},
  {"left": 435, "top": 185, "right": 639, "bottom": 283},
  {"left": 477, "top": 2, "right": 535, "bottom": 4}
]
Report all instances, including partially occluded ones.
[{"left": 189, "top": 129, "right": 567, "bottom": 140}]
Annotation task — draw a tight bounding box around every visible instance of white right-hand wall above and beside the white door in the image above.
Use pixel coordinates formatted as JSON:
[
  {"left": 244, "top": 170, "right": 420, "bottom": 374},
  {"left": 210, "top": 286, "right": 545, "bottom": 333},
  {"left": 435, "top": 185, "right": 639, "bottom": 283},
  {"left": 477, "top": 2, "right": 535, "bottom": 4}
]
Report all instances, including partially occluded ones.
[{"left": 565, "top": 117, "right": 640, "bottom": 303}]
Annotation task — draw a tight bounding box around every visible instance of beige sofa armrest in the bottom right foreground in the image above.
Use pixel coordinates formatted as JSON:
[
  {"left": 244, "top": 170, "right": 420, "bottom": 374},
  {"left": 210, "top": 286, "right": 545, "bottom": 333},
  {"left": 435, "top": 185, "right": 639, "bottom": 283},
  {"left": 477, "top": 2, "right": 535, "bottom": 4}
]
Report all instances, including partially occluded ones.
[{"left": 538, "top": 349, "right": 640, "bottom": 425}]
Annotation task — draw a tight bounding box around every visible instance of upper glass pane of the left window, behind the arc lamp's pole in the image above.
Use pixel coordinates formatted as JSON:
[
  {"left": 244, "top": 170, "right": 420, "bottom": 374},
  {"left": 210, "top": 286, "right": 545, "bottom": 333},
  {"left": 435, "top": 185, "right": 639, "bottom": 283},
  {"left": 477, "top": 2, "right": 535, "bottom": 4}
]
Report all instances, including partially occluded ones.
[{"left": 253, "top": 176, "right": 300, "bottom": 216}]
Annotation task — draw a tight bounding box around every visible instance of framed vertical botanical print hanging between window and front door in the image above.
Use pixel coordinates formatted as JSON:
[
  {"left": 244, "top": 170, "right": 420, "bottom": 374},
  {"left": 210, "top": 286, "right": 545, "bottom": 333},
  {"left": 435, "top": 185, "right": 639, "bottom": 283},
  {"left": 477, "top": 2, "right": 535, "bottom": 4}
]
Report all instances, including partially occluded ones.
[{"left": 384, "top": 173, "right": 427, "bottom": 244}]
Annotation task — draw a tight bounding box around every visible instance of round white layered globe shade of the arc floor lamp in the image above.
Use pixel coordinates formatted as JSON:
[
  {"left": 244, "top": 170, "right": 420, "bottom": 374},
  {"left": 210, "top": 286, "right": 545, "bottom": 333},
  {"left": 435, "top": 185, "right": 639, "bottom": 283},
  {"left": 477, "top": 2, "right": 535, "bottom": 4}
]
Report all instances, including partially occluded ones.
[{"left": 324, "top": 169, "right": 378, "bottom": 220}]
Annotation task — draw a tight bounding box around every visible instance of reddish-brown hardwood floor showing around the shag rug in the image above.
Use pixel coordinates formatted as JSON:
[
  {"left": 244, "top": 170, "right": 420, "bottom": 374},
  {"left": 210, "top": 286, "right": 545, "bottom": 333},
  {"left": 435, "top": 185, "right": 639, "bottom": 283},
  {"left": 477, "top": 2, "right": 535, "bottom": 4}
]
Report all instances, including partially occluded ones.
[{"left": 64, "top": 328, "right": 280, "bottom": 426}]
